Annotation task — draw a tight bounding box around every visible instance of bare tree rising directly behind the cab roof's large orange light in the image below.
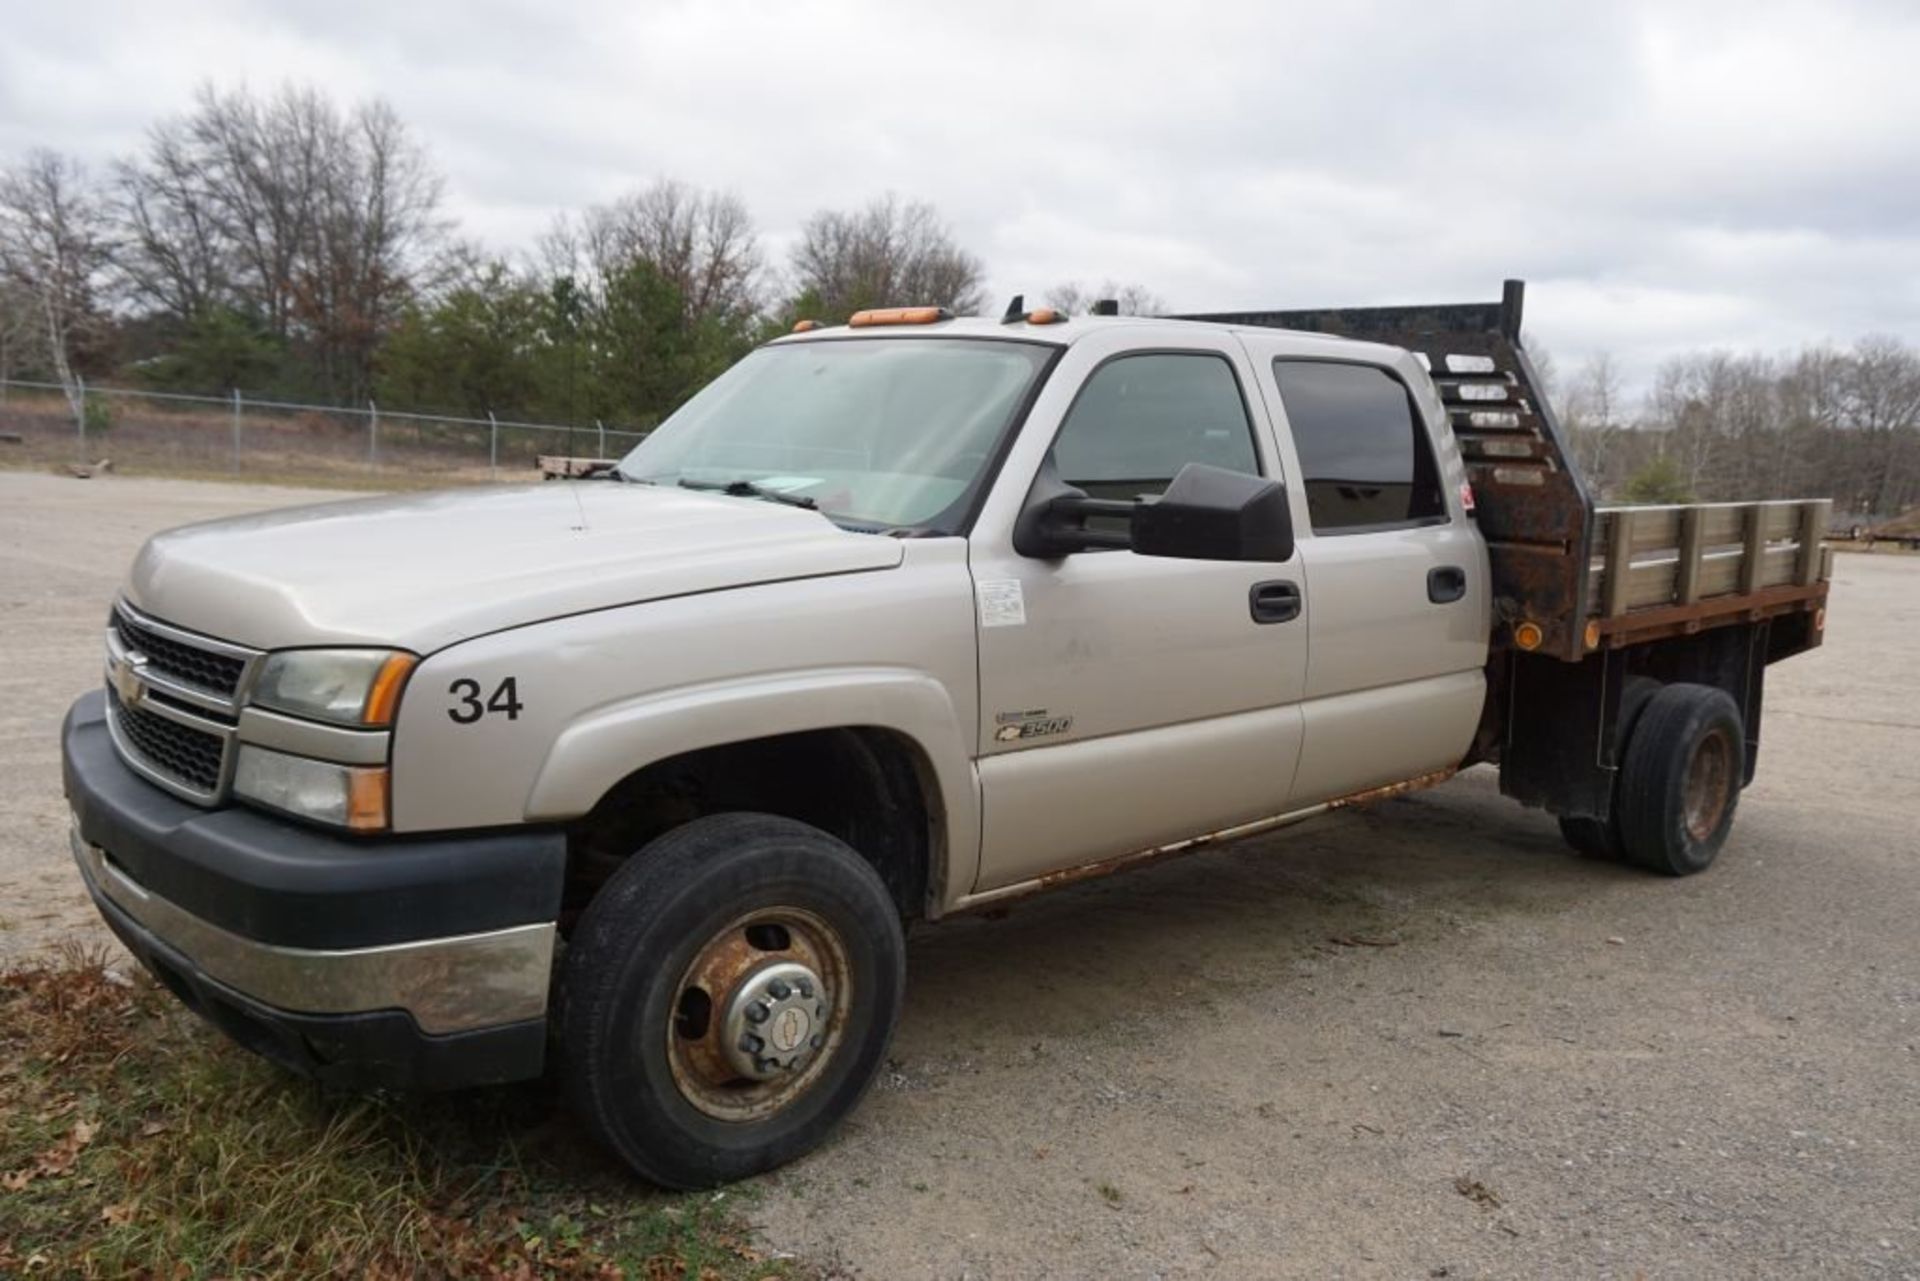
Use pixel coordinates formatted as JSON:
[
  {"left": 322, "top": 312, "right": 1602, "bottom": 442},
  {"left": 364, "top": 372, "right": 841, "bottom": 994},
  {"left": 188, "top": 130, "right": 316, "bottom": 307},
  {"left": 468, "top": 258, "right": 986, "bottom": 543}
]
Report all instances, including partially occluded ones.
[{"left": 791, "top": 196, "right": 985, "bottom": 317}]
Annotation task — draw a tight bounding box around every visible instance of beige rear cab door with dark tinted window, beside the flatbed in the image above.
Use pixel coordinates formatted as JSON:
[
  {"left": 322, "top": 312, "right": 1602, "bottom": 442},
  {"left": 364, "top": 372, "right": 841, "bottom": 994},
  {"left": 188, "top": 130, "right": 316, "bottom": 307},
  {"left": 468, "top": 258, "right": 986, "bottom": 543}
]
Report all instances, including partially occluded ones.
[{"left": 1250, "top": 355, "right": 1490, "bottom": 809}]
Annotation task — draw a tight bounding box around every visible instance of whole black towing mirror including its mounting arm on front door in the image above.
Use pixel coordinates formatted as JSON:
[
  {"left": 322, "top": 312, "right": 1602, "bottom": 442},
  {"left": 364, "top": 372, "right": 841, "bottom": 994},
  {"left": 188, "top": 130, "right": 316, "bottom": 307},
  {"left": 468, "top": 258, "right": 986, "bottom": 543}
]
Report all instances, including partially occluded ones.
[{"left": 1014, "top": 459, "right": 1294, "bottom": 561}]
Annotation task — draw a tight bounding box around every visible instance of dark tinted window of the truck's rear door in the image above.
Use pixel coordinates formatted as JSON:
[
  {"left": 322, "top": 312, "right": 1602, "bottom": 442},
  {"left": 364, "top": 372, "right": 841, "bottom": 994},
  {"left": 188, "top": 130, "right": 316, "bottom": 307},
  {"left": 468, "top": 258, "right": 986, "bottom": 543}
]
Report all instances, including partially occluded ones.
[{"left": 1273, "top": 359, "right": 1446, "bottom": 534}]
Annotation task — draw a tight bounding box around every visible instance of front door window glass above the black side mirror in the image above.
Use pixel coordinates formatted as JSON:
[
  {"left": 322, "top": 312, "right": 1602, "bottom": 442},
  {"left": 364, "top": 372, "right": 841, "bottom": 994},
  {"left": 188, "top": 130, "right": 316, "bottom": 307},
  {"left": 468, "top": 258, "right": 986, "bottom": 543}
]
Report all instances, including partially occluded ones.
[{"left": 1052, "top": 351, "right": 1261, "bottom": 501}]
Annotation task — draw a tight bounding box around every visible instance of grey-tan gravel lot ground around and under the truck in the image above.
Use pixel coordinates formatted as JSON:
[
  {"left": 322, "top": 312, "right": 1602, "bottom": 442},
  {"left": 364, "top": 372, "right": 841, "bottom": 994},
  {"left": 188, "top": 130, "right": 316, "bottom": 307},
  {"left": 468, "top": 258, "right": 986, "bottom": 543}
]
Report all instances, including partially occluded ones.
[{"left": 0, "top": 474, "right": 1920, "bottom": 1281}]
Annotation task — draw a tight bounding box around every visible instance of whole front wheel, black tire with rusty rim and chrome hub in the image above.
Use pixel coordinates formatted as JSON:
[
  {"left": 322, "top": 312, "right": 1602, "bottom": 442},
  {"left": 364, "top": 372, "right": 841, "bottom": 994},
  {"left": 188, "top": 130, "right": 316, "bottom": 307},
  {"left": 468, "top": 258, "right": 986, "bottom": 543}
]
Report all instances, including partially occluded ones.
[{"left": 561, "top": 814, "right": 906, "bottom": 1189}]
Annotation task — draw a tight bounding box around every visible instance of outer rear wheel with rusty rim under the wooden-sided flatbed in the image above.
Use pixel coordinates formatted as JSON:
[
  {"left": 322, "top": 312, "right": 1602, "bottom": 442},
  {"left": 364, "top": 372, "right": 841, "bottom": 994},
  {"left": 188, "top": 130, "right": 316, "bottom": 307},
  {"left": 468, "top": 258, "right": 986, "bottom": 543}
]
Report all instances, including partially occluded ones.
[{"left": 1615, "top": 684, "right": 1747, "bottom": 876}]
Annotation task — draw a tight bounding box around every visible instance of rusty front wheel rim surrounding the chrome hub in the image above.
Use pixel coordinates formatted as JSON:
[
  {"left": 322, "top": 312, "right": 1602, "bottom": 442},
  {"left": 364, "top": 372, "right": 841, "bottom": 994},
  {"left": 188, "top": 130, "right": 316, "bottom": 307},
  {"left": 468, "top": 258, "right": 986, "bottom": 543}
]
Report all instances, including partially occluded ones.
[{"left": 666, "top": 906, "right": 852, "bottom": 1122}]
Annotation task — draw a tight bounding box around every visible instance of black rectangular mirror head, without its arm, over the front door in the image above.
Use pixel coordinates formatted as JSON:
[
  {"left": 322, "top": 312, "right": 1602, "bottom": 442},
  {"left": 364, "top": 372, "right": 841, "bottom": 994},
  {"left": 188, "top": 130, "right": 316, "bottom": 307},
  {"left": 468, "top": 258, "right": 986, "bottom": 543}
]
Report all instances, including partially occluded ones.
[{"left": 1129, "top": 463, "right": 1294, "bottom": 561}]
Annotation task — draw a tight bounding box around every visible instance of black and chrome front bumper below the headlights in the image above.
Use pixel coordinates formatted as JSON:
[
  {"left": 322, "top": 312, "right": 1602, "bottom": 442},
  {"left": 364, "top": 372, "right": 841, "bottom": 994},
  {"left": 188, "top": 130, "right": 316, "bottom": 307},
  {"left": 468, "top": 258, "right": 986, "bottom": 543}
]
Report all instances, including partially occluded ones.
[{"left": 61, "top": 693, "right": 566, "bottom": 1089}]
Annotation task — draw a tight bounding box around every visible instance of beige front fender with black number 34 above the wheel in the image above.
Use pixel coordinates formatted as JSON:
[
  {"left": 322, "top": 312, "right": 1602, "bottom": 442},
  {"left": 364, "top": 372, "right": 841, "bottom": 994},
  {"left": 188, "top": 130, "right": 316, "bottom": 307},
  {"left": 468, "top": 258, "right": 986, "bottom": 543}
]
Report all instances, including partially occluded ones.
[{"left": 392, "top": 538, "right": 979, "bottom": 899}]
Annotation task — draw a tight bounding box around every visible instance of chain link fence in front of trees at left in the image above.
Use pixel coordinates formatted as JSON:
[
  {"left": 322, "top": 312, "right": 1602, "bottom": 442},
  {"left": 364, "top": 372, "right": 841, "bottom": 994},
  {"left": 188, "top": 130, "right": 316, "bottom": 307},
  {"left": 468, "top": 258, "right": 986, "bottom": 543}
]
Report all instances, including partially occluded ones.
[{"left": 0, "top": 378, "right": 645, "bottom": 488}]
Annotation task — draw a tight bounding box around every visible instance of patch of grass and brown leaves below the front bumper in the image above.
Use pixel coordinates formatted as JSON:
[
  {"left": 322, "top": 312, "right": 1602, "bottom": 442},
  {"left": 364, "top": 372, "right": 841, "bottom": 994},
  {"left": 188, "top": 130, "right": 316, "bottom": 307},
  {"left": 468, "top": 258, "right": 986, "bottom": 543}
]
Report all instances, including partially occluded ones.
[{"left": 0, "top": 955, "right": 803, "bottom": 1281}]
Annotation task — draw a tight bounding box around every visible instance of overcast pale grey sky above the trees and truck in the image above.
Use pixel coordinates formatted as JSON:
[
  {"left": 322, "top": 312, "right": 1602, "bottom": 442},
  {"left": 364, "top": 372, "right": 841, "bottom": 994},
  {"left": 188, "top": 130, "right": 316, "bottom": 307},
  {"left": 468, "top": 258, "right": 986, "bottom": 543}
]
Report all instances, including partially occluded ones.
[{"left": 0, "top": 0, "right": 1920, "bottom": 393}]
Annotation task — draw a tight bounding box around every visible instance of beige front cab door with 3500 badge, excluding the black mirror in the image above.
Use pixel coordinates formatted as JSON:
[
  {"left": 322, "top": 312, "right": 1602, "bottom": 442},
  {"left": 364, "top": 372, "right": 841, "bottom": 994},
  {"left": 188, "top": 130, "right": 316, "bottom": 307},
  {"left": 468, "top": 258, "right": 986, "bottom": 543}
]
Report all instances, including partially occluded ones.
[{"left": 970, "top": 326, "right": 1306, "bottom": 889}]
